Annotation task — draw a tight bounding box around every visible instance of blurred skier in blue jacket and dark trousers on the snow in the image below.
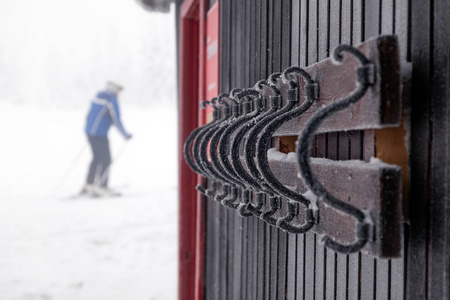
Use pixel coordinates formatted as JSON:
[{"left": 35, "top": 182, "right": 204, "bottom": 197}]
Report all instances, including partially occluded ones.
[{"left": 81, "top": 81, "right": 131, "bottom": 197}]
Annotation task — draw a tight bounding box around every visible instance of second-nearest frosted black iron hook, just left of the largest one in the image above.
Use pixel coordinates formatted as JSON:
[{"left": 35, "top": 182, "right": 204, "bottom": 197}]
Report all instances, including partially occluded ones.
[{"left": 256, "top": 67, "right": 318, "bottom": 234}]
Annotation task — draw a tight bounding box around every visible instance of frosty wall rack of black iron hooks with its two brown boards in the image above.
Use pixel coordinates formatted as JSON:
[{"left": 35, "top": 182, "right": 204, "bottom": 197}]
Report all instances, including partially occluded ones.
[{"left": 183, "top": 37, "right": 402, "bottom": 257}]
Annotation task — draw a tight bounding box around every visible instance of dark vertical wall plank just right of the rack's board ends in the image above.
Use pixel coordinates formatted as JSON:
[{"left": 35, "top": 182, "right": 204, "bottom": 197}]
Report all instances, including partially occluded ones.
[{"left": 406, "top": 1, "right": 432, "bottom": 299}]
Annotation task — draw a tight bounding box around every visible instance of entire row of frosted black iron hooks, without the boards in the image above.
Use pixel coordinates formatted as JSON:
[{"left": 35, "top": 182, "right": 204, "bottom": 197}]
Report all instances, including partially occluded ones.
[{"left": 183, "top": 45, "right": 375, "bottom": 253}]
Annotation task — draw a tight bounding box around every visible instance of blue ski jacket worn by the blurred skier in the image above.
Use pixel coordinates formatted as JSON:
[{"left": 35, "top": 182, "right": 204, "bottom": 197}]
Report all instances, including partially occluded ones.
[{"left": 85, "top": 91, "right": 131, "bottom": 138}]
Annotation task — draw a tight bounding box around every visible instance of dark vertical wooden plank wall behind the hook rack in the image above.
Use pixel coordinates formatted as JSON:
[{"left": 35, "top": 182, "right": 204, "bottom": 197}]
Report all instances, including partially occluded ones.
[{"left": 201, "top": 0, "right": 450, "bottom": 299}]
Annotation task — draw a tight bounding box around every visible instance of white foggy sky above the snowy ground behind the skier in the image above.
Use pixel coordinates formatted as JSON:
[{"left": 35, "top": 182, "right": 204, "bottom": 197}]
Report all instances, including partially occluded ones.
[{"left": 0, "top": 0, "right": 176, "bottom": 107}]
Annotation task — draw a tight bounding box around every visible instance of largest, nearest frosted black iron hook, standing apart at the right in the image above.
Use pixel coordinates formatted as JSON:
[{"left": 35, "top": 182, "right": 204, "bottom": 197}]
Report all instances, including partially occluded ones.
[{"left": 297, "top": 45, "right": 375, "bottom": 253}]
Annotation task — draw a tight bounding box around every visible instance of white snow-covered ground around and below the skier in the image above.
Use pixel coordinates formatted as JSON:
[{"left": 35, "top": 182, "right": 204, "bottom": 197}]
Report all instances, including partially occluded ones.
[{"left": 0, "top": 102, "right": 177, "bottom": 300}]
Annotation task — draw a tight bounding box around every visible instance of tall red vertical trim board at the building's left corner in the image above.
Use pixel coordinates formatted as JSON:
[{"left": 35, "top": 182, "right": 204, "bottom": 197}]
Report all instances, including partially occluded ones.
[{"left": 178, "top": 0, "right": 199, "bottom": 300}]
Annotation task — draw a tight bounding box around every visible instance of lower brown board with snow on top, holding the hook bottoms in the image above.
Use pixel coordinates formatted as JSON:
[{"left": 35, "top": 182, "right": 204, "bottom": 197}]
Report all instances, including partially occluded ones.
[{"left": 269, "top": 155, "right": 402, "bottom": 257}]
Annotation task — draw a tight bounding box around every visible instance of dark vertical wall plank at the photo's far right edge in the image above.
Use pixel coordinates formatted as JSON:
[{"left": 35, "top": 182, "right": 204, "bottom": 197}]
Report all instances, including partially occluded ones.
[{"left": 428, "top": 0, "right": 450, "bottom": 299}]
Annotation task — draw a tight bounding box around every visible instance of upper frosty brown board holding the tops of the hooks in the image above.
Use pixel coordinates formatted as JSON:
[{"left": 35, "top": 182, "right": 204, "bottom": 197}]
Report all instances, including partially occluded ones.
[{"left": 275, "top": 36, "right": 401, "bottom": 136}]
